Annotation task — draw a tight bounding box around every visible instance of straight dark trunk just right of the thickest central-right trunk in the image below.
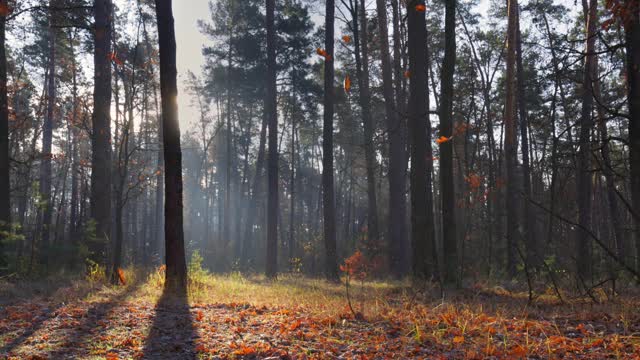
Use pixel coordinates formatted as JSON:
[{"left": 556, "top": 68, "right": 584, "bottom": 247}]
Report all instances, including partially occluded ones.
[{"left": 440, "top": 0, "right": 464, "bottom": 284}]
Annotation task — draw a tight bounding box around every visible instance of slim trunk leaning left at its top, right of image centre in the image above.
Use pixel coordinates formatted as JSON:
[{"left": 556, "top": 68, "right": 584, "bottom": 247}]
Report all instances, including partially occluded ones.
[{"left": 352, "top": 0, "right": 381, "bottom": 255}]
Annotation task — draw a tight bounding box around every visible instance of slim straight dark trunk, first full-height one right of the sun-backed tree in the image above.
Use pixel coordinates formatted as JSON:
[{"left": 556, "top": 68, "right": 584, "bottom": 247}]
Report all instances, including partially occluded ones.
[{"left": 265, "top": 0, "right": 278, "bottom": 278}]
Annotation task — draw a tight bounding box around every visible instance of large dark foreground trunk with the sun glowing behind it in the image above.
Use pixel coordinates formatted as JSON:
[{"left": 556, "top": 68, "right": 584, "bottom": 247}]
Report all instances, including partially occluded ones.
[{"left": 156, "top": 0, "right": 187, "bottom": 294}]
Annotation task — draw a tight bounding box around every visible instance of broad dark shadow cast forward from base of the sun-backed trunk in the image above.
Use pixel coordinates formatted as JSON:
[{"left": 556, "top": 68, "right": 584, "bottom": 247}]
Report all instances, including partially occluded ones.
[{"left": 142, "top": 290, "right": 198, "bottom": 359}]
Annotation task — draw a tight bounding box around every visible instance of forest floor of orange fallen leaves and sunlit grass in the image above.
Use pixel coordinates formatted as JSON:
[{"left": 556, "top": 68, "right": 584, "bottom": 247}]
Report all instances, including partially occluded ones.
[{"left": 0, "top": 272, "right": 640, "bottom": 360}]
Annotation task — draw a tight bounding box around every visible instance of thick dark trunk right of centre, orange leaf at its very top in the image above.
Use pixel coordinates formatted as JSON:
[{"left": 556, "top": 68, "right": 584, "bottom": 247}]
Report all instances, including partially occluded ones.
[{"left": 407, "top": 1, "right": 437, "bottom": 278}]
